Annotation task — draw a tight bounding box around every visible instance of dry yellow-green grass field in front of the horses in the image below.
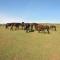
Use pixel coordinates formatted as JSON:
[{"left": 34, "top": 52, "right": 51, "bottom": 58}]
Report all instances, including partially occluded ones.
[{"left": 0, "top": 25, "right": 60, "bottom": 60}]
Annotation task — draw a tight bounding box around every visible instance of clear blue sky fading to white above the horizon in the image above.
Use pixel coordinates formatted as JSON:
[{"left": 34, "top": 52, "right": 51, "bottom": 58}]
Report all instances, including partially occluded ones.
[{"left": 0, "top": 0, "right": 60, "bottom": 23}]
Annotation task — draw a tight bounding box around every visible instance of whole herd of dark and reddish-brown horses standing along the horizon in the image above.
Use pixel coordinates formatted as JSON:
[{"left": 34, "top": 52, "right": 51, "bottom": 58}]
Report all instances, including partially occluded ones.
[{"left": 5, "top": 22, "right": 56, "bottom": 34}]
